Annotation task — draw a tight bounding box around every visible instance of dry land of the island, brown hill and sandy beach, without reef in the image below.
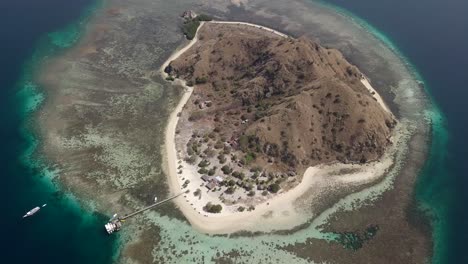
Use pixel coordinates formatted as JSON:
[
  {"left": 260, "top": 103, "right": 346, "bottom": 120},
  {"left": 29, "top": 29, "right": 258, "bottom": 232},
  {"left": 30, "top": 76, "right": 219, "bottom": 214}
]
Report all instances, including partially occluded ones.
[{"left": 162, "top": 12, "right": 397, "bottom": 233}]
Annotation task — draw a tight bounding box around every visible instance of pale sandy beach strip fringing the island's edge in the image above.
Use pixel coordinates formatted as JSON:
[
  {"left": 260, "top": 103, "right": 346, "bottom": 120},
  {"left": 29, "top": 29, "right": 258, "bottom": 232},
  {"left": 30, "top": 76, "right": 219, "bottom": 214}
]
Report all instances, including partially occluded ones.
[{"left": 161, "top": 21, "right": 400, "bottom": 234}]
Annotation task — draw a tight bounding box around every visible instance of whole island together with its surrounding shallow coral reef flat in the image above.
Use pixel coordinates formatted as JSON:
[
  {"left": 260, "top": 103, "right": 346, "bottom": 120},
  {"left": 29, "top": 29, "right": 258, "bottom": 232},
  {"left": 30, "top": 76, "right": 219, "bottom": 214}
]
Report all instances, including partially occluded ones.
[{"left": 33, "top": 0, "right": 437, "bottom": 263}]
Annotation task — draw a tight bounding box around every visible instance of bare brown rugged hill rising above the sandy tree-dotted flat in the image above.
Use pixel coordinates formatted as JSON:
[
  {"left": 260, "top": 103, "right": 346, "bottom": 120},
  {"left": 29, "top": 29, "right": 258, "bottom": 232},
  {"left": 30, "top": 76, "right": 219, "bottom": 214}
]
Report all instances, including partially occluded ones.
[{"left": 166, "top": 23, "right": 396, "bottom": 169}]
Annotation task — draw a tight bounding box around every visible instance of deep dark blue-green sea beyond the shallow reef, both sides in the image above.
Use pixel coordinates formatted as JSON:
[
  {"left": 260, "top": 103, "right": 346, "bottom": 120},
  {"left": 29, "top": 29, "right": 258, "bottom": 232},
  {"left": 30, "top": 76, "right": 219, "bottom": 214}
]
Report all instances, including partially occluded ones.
[{"left": 0, "top": 0, "right": 468, "bottom": 263}]
